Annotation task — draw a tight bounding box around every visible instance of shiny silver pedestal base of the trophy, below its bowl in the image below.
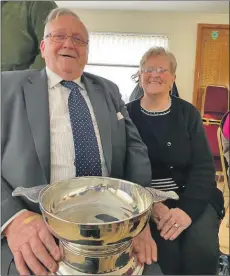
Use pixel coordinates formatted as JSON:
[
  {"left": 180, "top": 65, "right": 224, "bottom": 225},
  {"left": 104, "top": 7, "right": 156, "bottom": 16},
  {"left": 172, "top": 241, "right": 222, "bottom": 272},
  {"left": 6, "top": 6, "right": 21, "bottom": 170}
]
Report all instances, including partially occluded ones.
[{"left": 56, "top": 238, "right": 140, "bottom": 276}]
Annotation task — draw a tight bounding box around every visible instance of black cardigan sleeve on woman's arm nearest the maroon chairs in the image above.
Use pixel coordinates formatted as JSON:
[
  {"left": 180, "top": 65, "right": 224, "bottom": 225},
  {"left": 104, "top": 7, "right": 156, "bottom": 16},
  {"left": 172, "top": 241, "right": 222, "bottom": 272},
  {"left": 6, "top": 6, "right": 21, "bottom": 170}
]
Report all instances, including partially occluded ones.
[{"left": 178, "top": 108, "right": 216, "bottom": 221}]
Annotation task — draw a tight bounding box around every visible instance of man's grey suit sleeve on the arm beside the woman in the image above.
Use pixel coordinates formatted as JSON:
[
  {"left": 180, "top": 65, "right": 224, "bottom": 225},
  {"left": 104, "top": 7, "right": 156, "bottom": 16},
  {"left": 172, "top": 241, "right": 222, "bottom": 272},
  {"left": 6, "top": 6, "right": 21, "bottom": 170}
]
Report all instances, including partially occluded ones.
[{"left": 109, "top": 86, "right": 152, "bottom": 187}]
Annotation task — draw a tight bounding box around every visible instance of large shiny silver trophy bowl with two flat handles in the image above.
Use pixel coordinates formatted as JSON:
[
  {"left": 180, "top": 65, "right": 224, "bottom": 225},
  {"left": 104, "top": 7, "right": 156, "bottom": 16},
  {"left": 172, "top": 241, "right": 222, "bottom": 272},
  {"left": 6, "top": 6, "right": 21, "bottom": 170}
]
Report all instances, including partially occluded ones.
[{"left": 12, "top": 177, "right": 178, "bottom": 275}]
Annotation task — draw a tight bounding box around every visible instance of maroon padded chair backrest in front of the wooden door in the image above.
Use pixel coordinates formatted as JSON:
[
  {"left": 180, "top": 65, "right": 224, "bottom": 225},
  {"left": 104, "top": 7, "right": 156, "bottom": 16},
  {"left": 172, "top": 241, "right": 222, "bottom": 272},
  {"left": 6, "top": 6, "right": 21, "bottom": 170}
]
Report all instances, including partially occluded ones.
[{"left": 201, "top": 85, "right": 229, "bottom": 123}]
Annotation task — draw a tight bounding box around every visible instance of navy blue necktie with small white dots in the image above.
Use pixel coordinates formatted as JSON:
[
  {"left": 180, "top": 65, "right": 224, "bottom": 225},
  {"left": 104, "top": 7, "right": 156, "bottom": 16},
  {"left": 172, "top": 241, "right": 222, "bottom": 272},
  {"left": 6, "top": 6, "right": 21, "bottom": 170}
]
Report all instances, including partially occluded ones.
[{"left": 61, "top": 81, "right": 102, "bottom": 176}]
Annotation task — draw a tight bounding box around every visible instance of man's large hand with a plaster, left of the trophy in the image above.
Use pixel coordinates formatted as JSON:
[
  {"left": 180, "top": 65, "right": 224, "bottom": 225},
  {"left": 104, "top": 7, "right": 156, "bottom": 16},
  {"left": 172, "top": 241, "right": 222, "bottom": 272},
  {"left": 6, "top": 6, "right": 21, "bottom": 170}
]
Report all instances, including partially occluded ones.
[{"left": 4, "top": 211, "right": 61, "bottom": 275}]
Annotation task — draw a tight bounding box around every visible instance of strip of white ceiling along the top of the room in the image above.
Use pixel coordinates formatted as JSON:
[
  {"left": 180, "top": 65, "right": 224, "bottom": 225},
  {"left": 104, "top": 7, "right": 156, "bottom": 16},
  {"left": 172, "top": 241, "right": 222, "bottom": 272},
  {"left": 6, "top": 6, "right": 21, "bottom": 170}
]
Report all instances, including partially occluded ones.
[{"left": 55, "top": 0, "right": 229, "bottom": 13}]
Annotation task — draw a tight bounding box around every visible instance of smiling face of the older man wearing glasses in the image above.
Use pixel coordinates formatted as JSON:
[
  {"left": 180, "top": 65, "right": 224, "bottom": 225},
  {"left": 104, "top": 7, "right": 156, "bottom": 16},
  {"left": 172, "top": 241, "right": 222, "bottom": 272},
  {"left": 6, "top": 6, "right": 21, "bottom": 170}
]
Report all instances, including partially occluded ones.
[{"left": 40, "top": 15, "right": 88, "bottom": 80}]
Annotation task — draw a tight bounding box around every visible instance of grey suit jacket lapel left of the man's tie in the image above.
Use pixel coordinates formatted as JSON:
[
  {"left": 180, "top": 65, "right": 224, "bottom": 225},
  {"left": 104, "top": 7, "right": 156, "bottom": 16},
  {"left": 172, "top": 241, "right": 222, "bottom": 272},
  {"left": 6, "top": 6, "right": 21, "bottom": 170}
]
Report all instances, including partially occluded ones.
[{"left": 24, "top": 69, "right": 50, "bottom": 183}]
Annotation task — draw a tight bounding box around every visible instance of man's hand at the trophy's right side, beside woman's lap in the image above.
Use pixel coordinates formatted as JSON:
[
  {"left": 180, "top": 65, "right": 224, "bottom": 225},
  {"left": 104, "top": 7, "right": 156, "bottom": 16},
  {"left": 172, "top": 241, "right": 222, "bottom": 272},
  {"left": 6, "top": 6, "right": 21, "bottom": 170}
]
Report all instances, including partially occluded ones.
[{"left": 133, "top": 224, "right": 157, "bottom": 265}]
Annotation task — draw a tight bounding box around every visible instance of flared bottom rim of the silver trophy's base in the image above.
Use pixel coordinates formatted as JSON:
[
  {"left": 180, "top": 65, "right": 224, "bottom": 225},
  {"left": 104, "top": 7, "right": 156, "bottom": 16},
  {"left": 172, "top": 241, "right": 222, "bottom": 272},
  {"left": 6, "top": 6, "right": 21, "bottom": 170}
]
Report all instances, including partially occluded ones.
[{"left": 50, "top": 260, "right": 144, "bottom": 276}]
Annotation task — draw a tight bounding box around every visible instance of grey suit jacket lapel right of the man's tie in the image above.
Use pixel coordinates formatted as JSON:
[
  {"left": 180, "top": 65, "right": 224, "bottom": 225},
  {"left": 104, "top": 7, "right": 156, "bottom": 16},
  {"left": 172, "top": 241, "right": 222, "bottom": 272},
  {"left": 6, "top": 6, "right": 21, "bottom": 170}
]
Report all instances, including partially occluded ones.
[{"left": 82, "top": 75, "right": 112, "bottom": 174}]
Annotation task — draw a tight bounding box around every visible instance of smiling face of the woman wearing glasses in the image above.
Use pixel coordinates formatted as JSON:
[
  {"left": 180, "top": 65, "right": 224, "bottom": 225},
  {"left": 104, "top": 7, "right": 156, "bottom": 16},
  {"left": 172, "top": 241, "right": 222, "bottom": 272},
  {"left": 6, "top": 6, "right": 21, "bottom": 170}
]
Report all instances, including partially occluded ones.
[{"left": 139, "top": 56, "right": 176, "bottom": 95}]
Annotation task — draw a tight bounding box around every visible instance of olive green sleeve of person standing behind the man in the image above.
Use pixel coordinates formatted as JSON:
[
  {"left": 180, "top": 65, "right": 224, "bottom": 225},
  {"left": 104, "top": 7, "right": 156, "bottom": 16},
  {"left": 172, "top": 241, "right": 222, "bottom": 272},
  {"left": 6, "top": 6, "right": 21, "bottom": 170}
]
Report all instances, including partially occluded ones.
[{"left": 29, "top": 1, "right": 57, "bottom": 69}]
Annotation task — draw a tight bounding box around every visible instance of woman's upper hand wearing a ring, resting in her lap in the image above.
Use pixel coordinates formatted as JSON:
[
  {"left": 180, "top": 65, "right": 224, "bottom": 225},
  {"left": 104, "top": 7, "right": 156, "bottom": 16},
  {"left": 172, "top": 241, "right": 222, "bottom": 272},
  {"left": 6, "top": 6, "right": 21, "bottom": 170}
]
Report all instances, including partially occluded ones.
[{"left": 157, "top": 208, "right": 192, "bottom": 240}]
